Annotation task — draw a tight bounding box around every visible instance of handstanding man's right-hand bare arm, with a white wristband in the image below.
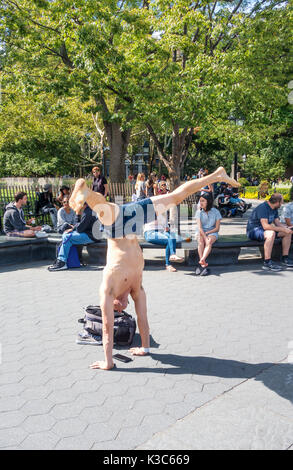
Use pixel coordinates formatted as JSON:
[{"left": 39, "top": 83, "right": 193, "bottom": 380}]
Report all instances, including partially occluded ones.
[{"left": 129, "top": 286, "right": 150, "bottom": 356}]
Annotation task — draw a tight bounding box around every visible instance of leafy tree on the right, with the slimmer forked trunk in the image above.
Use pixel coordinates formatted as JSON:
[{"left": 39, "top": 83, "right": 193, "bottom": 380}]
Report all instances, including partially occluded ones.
[{"left": 134, "top": 0, "right": 292, "bottom": 187}]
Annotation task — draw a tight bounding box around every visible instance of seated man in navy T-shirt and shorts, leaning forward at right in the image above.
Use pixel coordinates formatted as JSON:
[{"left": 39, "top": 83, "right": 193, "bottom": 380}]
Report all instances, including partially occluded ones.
[{"left": 246, "top": 193, "right": 293, "bottom": 271}]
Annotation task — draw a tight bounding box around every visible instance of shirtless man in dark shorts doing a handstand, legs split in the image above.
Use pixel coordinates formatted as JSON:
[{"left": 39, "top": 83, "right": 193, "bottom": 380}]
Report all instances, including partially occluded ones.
[{"left": 70, "top": 167, "right": 240, "bottom": 370}]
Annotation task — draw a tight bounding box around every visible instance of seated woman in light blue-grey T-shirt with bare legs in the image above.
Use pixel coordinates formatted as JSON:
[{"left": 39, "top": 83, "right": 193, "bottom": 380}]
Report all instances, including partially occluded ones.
[{"left": 195, "top": 193, "right": 222, "bottom": 268}]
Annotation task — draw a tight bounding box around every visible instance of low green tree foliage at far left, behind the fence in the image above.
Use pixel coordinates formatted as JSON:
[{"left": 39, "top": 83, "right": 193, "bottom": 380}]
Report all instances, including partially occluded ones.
[{"left": 0, "top": 87, "right": 96, "bottom": 176}]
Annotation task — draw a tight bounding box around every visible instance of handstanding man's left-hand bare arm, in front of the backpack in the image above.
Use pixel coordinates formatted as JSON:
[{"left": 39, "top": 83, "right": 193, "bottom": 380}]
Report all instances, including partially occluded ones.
[{"left": 90, "top": 280, "right": 114, "bottom": 370}]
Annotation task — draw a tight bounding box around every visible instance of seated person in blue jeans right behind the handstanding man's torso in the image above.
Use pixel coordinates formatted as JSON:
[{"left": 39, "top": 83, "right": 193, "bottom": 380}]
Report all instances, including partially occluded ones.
[{"left": 144, "top": 214, "right": 184, "bottom": 272}]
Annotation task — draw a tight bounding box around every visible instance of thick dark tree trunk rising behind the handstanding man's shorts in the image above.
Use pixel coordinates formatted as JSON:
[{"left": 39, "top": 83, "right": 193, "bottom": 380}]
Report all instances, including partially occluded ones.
[{"left": 104, "top": 121, "right": 131, "bottom": 183}]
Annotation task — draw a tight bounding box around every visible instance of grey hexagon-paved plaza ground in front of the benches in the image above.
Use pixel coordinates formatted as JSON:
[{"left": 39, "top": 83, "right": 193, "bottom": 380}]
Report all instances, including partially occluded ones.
[{"left": 0, "top": 201, "right": 293, "bottom": 450}]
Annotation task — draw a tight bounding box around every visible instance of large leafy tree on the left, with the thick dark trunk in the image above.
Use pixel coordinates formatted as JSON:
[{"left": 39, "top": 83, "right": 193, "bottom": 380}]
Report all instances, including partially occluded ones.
[{"left": 0, "top": 0, "right": 149, "bottom": 181}]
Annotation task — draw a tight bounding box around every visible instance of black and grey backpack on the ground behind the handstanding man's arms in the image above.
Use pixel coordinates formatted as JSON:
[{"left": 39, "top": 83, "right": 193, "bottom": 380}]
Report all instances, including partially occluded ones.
[{"left": 79, "top": 305, "right": 136, "bottom": 346}]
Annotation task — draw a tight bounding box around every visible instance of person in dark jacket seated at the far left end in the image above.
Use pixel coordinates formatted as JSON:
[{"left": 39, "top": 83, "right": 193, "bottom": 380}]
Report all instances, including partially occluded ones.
[{"left": 3, "top": 192, "right": 42, "bottom": 238}]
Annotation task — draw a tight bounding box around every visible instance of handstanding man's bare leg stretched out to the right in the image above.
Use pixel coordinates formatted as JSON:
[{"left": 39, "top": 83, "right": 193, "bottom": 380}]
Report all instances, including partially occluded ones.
[{"left": 151, "top": 167, "right": 240, "bottom": 215}]
